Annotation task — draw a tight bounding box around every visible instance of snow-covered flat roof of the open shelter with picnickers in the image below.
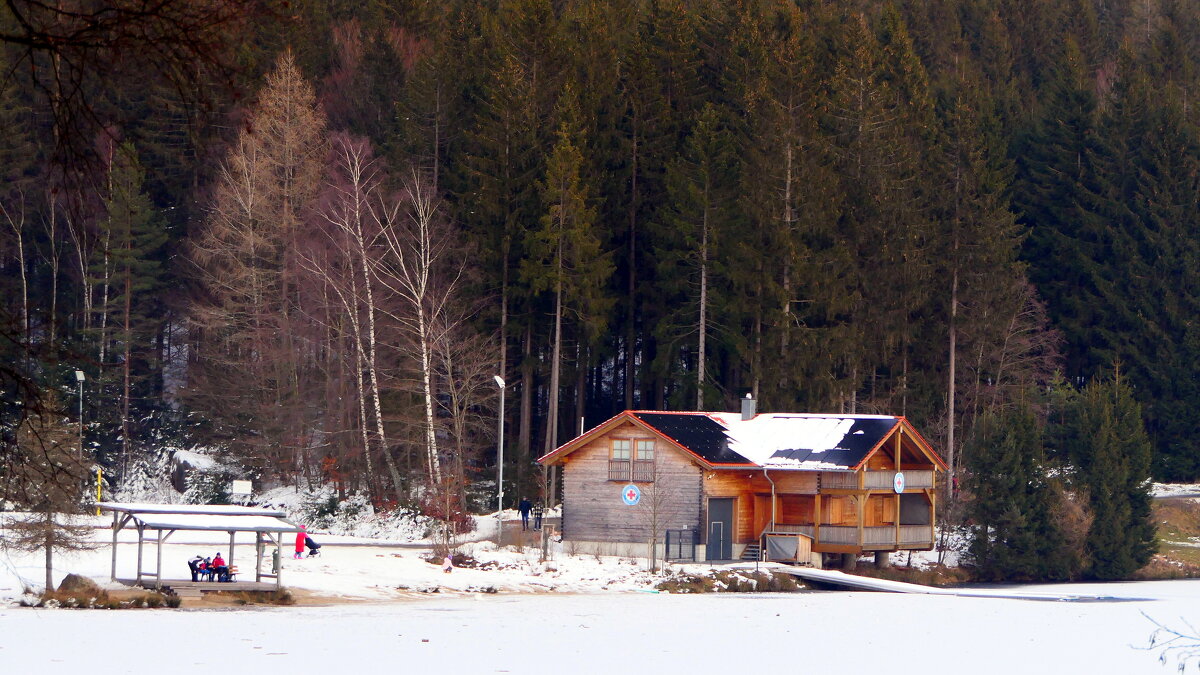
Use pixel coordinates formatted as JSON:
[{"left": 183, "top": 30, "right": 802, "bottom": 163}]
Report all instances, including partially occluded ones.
[{"left": 96, "top": 502, "right": 300, "bottom": 532}]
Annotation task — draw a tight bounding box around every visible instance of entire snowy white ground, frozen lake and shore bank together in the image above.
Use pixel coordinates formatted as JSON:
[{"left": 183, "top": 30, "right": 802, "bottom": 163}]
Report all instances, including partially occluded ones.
[{"left": 7, "top": 494, "right": 1200, "bottom": 675}]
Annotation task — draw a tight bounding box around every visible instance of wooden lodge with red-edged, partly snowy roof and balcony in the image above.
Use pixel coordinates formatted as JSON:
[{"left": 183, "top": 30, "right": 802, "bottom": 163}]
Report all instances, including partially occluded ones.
[{"left": 538, "top": 398, "right": 946, "bottom": 566}]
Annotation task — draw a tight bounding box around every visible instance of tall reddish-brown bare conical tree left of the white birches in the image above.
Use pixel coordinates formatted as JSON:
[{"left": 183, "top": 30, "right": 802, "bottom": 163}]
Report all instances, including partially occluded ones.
[{"left": 190, "top": 52, "right": 325, "bottom": 473}]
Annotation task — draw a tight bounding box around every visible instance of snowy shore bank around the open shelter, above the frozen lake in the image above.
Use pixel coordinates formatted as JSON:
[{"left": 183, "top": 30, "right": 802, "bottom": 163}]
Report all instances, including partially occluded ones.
[{"left": 0, "top": 514, "right": 661, "bottom": 595}]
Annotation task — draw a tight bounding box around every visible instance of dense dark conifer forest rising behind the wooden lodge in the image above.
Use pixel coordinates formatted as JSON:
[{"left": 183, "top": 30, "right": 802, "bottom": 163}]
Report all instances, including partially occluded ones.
[{"left": 0, "top": 0, "right": 1200, "bottom": 566}]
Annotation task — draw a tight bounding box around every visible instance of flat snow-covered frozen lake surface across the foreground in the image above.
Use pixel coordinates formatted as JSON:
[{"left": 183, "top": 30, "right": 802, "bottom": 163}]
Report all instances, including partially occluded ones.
[{"left": 0, "top": 581, "right": 1200, "bottom": 675}]
